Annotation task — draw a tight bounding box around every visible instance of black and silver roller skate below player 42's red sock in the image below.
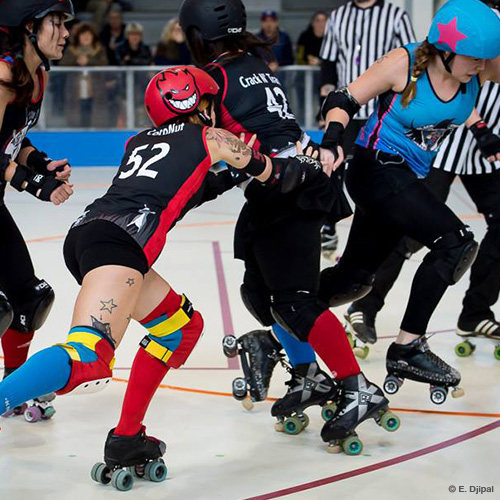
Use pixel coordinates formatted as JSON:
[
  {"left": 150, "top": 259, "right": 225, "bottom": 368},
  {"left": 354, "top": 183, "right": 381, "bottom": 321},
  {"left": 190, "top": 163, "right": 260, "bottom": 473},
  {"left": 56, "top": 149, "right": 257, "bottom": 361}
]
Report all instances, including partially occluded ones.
[{"left": 321, "top": 373, "right": 401, "bottom": 455}]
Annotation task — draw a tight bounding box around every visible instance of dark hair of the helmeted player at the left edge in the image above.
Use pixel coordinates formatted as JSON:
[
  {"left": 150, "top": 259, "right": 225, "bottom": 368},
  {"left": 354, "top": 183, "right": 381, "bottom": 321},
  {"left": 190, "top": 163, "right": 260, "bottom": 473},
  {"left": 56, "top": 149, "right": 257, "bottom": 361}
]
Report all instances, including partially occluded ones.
[{"left": 0, "top": 28, "right": 35, "bottom": 105}]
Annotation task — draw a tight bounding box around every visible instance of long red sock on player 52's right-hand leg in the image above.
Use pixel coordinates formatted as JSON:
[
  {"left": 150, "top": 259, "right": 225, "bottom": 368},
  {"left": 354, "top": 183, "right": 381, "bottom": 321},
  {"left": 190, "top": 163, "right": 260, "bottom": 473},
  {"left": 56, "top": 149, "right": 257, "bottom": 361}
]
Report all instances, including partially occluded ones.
[{"left": 115, "top": 290, "right": 182, "bottom": 436}]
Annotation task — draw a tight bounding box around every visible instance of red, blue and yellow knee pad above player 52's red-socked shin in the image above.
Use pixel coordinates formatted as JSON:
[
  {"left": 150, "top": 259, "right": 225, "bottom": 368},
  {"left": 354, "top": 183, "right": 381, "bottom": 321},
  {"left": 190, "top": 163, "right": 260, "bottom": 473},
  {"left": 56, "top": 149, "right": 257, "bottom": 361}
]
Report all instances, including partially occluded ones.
[{"left": 140, "top": 295, "right": 203, "bottom": 368}]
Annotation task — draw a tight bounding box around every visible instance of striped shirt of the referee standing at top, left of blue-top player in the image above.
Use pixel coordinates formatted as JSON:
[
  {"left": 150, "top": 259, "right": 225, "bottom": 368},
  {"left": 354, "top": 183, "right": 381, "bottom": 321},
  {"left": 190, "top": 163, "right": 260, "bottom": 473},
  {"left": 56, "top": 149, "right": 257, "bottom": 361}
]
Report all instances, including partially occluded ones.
[{"left": 320, "top": 0, "right": 415, "bottom": 120}]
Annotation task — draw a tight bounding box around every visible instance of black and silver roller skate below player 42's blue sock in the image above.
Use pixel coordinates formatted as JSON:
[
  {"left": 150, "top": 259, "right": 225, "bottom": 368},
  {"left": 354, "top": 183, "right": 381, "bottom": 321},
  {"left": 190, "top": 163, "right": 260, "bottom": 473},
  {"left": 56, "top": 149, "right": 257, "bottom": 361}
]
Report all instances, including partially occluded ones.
[{"left": 271, "top": 362, "right": 337, "bottom": 435}]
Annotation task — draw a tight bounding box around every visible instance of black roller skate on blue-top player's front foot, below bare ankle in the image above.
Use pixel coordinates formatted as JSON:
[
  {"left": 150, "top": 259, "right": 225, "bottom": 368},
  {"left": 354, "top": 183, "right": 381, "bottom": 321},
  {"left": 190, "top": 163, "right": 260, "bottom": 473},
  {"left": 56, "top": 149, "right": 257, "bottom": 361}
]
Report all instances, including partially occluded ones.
[{"left": 384, "top": 336, "right": 464, "bottom": 405}]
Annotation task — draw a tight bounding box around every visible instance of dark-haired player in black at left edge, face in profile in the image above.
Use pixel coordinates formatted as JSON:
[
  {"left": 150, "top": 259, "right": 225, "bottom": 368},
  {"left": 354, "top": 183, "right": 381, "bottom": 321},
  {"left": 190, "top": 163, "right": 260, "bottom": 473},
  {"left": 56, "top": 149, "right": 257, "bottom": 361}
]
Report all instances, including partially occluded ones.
[{"left": 0, "top": 0, "right": 74, "bottom": 422}]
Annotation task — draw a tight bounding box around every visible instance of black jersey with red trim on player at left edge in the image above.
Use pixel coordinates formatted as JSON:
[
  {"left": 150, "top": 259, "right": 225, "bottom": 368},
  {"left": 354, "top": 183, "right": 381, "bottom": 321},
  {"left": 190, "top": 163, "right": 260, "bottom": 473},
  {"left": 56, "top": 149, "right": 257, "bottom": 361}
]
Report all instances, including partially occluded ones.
[{"left": 0, "top": 57, "right": 45, "bottom": 204}]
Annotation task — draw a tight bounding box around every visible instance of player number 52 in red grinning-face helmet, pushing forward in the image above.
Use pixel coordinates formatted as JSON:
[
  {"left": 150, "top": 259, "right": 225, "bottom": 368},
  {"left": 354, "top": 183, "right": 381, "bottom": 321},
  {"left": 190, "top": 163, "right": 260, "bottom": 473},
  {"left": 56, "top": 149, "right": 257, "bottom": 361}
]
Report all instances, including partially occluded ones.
[{"left": 0, "top": 67, "right": 324, "bottom": 490}]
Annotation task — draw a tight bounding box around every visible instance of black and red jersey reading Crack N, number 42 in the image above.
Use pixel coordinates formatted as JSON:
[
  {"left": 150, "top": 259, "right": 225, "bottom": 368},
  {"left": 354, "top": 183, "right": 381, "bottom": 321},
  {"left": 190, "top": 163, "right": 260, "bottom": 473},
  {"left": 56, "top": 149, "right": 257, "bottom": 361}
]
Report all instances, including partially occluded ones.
[{"left": 205, "top": 54, "right": 302, "bottom": 156}]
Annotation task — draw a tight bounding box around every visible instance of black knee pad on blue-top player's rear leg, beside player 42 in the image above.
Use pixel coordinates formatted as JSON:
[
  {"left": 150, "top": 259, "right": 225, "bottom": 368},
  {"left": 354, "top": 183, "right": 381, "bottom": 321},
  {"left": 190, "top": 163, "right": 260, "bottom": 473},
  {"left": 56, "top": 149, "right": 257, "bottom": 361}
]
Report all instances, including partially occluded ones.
[{"left": 318, "top": 265, "right": 375, "bottom": 307}]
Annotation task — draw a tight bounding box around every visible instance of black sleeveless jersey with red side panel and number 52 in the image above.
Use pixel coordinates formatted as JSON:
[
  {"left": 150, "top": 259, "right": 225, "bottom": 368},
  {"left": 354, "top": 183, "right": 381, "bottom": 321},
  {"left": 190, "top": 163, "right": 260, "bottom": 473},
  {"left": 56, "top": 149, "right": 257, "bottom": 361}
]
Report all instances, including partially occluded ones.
[{"left": 72, "top": 123, "right": 212, "bottom": 265}]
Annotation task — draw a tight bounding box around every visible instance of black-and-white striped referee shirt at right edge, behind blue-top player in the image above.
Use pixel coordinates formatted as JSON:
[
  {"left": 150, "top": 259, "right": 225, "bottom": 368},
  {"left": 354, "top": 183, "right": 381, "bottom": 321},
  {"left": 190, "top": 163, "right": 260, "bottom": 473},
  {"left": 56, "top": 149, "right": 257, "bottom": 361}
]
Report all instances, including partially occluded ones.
[{"left": 433, "top": 82, "right": 500, "bottom": 175}]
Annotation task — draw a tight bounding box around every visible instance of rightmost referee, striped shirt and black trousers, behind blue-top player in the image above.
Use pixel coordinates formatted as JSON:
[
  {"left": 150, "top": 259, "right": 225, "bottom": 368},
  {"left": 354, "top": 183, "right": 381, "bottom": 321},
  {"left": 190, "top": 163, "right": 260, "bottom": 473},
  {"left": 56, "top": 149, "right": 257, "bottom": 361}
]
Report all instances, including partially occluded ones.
[{"left": 346, "top": 1, "right": 500, "bottom": 366}]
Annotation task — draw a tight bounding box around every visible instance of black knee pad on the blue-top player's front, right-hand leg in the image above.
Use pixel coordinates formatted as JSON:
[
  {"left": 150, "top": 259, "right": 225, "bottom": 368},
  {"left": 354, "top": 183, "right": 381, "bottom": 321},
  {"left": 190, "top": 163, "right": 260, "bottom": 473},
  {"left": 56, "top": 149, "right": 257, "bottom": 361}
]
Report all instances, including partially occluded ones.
[{"left": 424, "top": 226, "right": 479, "bottom": 285}]
